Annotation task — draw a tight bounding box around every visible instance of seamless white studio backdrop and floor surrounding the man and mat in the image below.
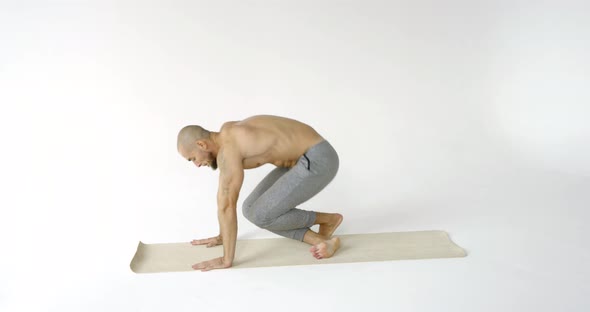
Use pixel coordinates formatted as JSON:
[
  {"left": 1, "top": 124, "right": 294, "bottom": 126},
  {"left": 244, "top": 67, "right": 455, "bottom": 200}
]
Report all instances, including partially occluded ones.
[{"left": 0, "top": 0, "right": 590, "bottom": 311}]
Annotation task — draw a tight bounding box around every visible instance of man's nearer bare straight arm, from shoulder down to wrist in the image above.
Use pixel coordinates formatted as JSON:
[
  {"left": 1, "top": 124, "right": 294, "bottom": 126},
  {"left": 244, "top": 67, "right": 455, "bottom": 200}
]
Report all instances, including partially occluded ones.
[{"left": 217, "top": 146, "right": 244, "bottom": 266}]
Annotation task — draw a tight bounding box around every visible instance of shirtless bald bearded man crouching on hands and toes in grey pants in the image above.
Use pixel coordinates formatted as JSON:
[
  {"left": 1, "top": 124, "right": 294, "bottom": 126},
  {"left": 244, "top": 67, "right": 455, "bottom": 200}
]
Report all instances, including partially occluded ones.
[{"left": 177, "top": 116, "right": 342, "bottom": 271}]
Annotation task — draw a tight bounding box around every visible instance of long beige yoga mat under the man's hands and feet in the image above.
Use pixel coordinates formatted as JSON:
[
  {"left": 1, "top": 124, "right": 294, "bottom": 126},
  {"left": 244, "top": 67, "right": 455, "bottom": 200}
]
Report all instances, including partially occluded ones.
[{"left": 131, "top": 231, "right": 466, "bottom": 273}]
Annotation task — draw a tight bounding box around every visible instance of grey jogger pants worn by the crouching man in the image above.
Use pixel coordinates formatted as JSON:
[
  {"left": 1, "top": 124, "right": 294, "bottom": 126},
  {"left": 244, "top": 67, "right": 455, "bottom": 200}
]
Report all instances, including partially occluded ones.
[{"left": 242, "top": 141, "right": 339, "bottom": 241}]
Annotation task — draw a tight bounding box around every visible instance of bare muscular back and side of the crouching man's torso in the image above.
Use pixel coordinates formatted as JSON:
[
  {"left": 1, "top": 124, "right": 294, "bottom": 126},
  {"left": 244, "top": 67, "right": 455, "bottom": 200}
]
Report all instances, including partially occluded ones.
[{"left": 220, "top": 115, "right": 323, "bottom": 169}]
